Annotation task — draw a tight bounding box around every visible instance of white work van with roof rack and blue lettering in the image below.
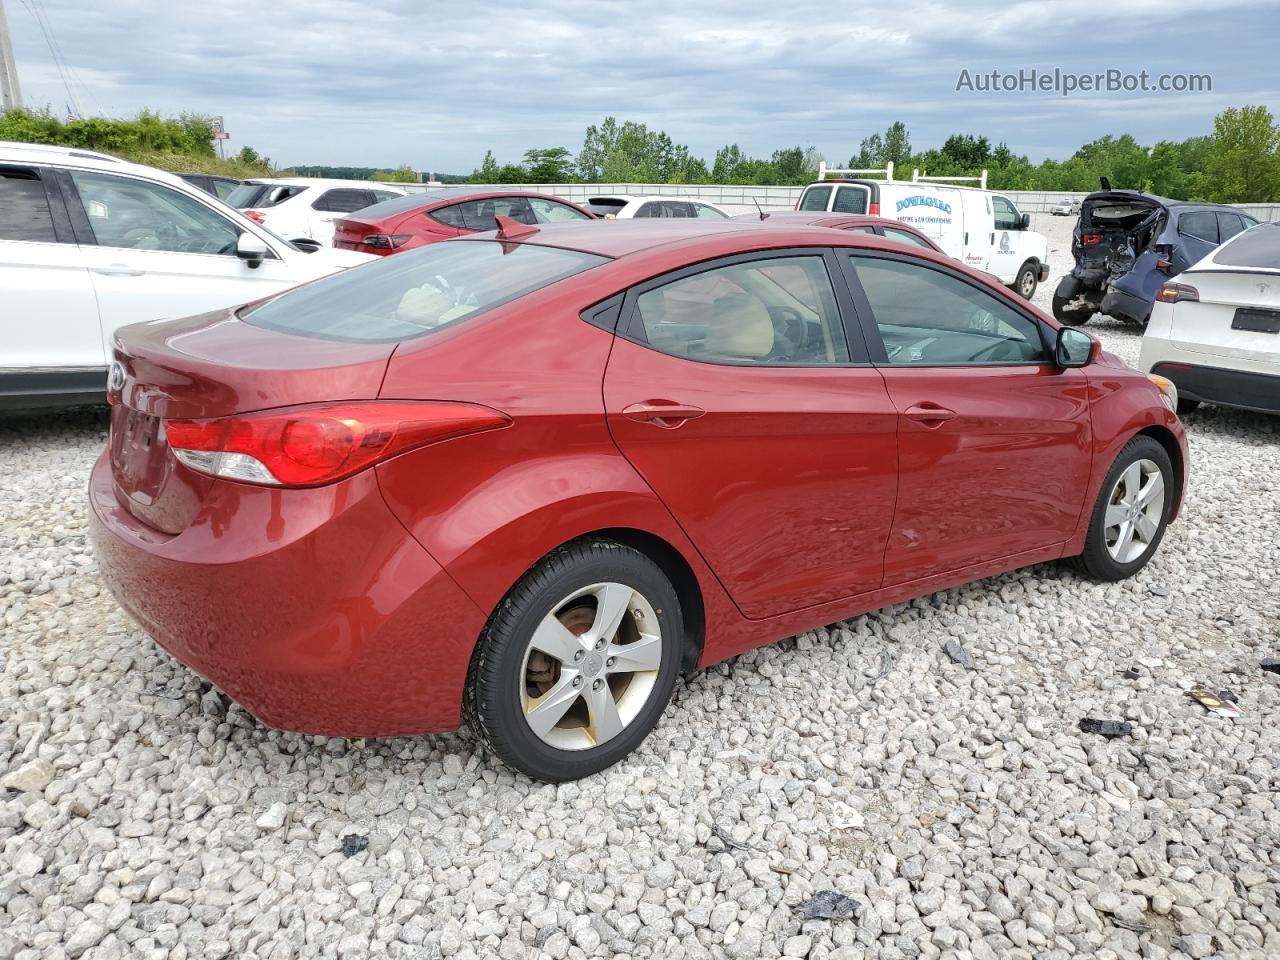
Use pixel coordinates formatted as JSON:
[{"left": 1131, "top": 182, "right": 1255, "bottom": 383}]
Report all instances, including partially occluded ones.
[{"left": 796, "top": 164, "right": 1048, "bottom": 300}]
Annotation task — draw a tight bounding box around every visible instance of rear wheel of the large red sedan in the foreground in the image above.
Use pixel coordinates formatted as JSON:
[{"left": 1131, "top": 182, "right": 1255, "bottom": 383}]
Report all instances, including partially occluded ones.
[{"left": 463, "top": 539, "right": 685, "bottom": 783}]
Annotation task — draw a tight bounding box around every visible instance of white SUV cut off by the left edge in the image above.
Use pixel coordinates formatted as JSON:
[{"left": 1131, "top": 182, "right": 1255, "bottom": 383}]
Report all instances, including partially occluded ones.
[{"left": 0, "top": 142, "right": 375, "bottom": 410}]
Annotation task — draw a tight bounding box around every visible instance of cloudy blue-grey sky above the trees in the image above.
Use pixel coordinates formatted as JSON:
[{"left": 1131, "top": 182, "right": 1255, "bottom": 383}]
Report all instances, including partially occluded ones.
[{"left": 0, "top": 0, "right": 1280, "bottom": 173}]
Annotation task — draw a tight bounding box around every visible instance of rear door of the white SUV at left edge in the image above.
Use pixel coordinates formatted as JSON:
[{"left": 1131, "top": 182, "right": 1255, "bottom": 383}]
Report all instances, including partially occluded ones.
[{"left": 0, "top": 164, "right": 106, "bottom": 376}]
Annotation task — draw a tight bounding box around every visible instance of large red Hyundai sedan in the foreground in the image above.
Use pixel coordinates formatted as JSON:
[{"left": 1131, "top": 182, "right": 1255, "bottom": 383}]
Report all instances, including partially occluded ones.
[{"left": 90, "top": 220, "right": 1187, "bottom": 781}]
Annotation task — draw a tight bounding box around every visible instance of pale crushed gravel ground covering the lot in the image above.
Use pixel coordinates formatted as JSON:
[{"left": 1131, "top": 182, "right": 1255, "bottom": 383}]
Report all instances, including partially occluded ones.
[{"left": 0, "top": 216, "right": 1280, "bottom": 960}]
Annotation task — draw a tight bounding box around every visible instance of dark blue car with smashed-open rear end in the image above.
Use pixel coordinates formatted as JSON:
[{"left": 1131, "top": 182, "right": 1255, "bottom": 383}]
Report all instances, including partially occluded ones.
[{"left": 1053, "top": 189, "right": 1257, "bottom": 326}]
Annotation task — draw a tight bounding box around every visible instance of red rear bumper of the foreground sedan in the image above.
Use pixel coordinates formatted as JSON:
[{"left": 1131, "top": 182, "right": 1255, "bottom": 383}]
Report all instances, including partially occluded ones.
[{"left": 90, "top": 454, "right": 484, "bottom": 736}]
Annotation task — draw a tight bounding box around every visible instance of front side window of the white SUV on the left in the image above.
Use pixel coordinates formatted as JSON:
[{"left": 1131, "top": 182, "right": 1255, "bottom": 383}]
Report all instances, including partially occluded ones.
[{"left": 70, "top": 170, "right": 239, "bottom": 256}]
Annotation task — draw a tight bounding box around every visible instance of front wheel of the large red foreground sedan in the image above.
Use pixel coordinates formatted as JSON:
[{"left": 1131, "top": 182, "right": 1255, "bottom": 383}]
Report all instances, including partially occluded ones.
[{"left": 1075, "top": 435, "right": 1175, "bottom": 581}]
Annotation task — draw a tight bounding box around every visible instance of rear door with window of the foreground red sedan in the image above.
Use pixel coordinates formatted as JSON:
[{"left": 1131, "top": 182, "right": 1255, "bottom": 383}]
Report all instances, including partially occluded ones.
[{"left": 604, "top": 248, "right": 896, "bottom": 618}]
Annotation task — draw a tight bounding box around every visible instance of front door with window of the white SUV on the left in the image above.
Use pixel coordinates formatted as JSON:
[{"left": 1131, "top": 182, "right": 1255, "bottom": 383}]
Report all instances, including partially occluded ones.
[{"left": 59, "top": 170, "right": 297, "bottom": 355}]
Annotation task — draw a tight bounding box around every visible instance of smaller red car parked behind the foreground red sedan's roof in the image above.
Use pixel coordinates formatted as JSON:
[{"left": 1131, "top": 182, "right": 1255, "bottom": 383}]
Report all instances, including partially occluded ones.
[{"left": 333, "top": 188, "right": 598, "bottom": 256}]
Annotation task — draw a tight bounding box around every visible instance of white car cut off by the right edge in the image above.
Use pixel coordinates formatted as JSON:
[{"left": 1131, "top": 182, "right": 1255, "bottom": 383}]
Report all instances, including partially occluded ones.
[{"left": 1138, "top": 224, "right": 1280, "bottom": 413}]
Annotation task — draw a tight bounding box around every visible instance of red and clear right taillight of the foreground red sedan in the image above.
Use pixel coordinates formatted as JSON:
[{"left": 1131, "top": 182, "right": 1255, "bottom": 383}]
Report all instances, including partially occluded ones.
[{"left": 164, "top": 401, "right": 511, "bottom": 486}]
